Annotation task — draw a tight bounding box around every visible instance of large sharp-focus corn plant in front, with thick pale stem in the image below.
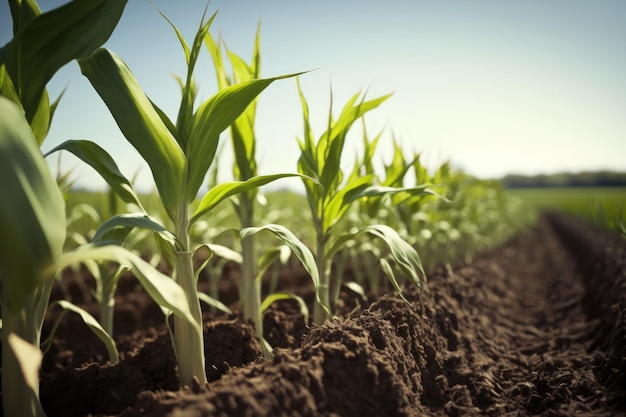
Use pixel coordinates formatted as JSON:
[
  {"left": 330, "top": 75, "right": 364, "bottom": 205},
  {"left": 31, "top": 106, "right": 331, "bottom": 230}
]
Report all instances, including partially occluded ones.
[{"left": 50, "top": 8, "right": 308, "bottom": 386}]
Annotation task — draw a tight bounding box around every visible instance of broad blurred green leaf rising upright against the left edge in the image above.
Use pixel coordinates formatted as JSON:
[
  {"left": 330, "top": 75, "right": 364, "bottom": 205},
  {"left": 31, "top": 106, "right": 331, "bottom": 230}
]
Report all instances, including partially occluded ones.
[{"left": 0, "top": 97, "right": 66, "bottom": 313}]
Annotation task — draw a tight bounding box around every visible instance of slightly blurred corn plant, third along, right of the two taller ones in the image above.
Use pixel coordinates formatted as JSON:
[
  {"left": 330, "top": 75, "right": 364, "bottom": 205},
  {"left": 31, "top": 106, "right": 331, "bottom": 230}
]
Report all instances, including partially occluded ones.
[{"left": 298, "top": 79, "right": 427, "bottom": 323}]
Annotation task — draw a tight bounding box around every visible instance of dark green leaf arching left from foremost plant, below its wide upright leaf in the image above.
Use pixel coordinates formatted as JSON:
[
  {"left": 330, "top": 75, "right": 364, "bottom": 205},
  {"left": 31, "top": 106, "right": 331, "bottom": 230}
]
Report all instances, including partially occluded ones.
[{"left": 45, "top": 140, "right": 145, "bottom": 211}]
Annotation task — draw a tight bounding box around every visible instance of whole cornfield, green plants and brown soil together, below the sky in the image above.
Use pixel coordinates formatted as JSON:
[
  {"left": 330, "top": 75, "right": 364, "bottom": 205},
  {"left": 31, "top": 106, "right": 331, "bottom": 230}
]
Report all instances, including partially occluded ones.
[{"left": 0, "top": 0, "right": 626, "bottom": 417}]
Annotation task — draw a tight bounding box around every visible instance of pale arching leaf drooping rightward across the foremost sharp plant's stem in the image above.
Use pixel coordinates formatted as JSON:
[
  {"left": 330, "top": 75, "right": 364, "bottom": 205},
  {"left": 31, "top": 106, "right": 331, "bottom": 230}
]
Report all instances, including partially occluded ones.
[{"left": 47, "top": 245, "right": 200, "bottom": 331}]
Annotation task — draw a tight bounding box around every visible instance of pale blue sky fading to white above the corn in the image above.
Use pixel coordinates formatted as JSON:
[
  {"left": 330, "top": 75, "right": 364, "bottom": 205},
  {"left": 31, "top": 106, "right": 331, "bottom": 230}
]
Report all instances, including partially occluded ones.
[{"left": 0, "top": 0, "right": 626, "bottom": 190}]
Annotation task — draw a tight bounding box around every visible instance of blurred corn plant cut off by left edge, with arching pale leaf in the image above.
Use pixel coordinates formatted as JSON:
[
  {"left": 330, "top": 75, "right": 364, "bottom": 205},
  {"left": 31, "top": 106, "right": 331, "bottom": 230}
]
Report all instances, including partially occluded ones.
[{"left": 0, "top": 97, "right": 193, "bottom": 416}]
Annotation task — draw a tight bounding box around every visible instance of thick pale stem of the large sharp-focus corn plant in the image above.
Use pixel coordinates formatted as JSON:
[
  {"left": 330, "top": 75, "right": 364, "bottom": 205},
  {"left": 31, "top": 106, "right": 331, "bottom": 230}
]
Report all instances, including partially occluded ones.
[{"left": 174, "top": 206, "right": 207, "bottom": 387}]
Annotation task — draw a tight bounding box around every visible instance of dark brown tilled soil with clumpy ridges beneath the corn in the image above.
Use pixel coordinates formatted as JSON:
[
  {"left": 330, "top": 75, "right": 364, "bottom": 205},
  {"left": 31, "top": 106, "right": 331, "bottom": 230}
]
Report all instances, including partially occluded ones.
[{"left": 1, "top": 214, "right": 626, "bottom": 417}]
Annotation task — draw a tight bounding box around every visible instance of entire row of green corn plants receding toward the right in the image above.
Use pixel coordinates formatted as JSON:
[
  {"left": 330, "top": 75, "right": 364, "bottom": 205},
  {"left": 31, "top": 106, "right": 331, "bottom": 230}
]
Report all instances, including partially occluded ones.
[{"left": 0, "top": 0, "right": 532, "bottom": 416}]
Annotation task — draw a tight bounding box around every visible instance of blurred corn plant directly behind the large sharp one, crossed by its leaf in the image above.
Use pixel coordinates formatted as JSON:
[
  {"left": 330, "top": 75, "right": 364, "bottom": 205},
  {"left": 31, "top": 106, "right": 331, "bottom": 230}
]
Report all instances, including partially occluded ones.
[{"left": 204, "top": 25, "right": 315, "bottom": 353}]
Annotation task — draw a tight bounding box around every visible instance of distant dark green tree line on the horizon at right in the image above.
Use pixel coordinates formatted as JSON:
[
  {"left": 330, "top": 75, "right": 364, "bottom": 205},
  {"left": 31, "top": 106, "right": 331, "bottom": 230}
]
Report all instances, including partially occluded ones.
[{"left": 500, "top": 171, "right": 626, "bottom": 188}]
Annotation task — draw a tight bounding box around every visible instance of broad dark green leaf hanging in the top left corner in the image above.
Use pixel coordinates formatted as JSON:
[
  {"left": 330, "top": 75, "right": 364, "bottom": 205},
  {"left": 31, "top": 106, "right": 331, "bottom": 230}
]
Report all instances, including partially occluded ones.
[{"left": 5, "top": 0, "right": 127, "bottom": 122}]
